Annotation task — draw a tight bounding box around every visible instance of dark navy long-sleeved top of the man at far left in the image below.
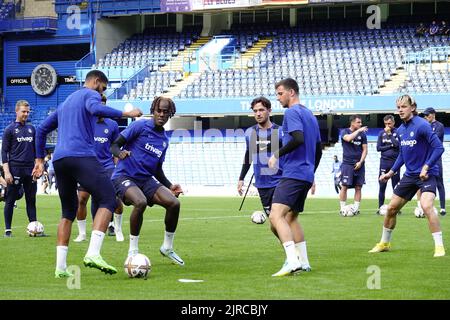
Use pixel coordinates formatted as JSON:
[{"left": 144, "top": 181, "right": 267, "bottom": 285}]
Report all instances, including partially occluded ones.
[{"left": 2, "top": 122, "right": 36, "bottom": 167}]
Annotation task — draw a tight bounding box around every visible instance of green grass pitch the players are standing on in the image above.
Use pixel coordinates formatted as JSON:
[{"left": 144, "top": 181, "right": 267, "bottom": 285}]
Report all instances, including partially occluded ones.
[{"left": 0, "top": 196, "right": 450, "bottom": 300}]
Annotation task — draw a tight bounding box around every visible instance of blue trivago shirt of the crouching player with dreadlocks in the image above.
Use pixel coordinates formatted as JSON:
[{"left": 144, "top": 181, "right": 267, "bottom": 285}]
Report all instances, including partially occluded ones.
[{"left": 111, "top": 119, "right": 169, "bottom": 181}]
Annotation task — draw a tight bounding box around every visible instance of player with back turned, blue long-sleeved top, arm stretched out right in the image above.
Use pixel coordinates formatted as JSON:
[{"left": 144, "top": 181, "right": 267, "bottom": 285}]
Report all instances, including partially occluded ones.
[{"left": 33, "top": 70, "right": 142, "bottom": 278}]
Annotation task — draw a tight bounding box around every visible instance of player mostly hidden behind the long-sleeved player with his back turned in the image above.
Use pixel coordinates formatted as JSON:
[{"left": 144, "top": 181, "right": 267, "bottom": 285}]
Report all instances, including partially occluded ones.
[{"left": 73, "top": 95, "right": 124, "bottom": 242}]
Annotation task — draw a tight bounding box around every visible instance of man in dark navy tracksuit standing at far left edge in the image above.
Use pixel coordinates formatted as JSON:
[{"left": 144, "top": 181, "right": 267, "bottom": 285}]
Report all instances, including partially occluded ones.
[{"left": 2, "top": 100, "right": 37, "bottom": 237}]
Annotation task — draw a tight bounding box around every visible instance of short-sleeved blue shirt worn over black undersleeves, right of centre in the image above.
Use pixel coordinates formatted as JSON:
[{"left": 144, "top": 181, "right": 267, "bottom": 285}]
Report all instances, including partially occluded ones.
[{"left": 280, "top": 104, "right": 321, "bottom": 183}]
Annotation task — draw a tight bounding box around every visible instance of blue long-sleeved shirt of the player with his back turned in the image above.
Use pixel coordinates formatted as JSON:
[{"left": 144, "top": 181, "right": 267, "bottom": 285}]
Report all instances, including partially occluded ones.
[{"left": 36, "top": 88, "right": 122, "bottom": 161}]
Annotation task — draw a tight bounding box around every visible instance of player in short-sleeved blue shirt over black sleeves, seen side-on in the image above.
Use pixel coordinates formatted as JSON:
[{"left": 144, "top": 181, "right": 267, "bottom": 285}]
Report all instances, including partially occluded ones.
[{"left": 269, "top": 78, "right": 322, "bottom": 277}]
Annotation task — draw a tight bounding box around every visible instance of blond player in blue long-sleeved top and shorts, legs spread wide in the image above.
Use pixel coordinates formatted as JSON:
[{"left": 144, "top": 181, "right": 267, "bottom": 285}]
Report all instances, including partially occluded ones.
[{"left": 369, "top": 95, "right": 445, "bottom": 257}]
